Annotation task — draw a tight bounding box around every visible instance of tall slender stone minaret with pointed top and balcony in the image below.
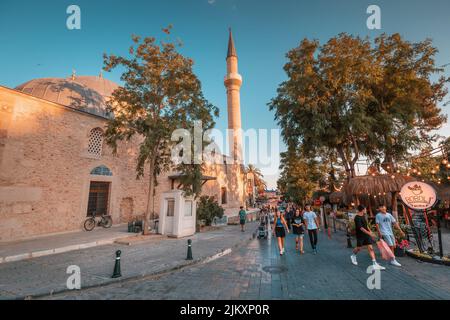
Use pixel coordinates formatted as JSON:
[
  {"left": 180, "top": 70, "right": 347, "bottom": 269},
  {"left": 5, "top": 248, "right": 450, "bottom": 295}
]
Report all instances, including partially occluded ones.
[{"left": 224, "top": 29, "right": 242, "bottom": 163}]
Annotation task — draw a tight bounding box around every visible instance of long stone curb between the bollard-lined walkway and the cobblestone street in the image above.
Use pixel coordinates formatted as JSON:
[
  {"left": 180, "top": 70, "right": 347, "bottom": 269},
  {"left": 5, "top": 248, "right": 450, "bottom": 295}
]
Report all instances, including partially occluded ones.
[{"left": 14, "top": 226, "right": 256, "bottom": 300}]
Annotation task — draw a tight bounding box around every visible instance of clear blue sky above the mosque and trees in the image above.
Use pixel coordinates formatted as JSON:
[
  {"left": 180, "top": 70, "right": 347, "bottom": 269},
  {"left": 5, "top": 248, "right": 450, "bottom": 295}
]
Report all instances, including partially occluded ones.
[{"left": 0, "top": 0, "right": 450, "bottom": 187}]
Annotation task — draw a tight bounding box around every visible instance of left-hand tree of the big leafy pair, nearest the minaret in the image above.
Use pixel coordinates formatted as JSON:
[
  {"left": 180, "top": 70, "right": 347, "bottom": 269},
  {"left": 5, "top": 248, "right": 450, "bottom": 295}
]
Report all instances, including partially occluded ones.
[{"left": 269, "top": 34, "right": 373, "bottom": 177}]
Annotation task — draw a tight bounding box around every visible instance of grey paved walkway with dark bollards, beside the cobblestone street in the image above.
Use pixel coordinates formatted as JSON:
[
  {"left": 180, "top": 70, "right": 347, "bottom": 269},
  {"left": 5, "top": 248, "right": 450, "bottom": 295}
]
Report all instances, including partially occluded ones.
[{"left": 0, "top": 223, "right": 257, "bottom": 299}]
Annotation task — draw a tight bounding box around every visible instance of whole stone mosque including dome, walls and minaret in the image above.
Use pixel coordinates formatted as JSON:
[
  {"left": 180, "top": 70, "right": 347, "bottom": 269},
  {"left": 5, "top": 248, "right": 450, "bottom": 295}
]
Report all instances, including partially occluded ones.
[{"left": 0, "top": 31, "right": 254, "bottom": 242}]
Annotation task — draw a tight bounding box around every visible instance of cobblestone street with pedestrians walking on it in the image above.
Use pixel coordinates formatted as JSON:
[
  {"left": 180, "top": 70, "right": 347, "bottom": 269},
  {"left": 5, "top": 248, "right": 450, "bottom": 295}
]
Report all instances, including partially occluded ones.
[{"left": 46, "top": 233, "right": 450, "bottom": 300}]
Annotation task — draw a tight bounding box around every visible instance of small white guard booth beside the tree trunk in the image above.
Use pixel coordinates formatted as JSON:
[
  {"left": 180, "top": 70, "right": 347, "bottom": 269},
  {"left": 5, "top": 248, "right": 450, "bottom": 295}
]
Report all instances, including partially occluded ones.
[{"left": 158, "top": 190, "right": 197, "bottom": 238}]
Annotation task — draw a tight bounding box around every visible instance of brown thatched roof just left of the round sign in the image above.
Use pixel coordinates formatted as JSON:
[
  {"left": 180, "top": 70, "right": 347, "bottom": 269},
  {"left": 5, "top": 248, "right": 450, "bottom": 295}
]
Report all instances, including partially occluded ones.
[{"left": 344, "top": 174, "right": 416, "bottom": 195}]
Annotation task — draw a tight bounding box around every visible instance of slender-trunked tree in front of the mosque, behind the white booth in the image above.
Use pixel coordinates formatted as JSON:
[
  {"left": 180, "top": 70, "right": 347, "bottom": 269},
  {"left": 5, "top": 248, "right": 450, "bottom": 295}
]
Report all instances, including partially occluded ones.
[{"left": 104, "top": 27, "right": 218, "bottom": 234}]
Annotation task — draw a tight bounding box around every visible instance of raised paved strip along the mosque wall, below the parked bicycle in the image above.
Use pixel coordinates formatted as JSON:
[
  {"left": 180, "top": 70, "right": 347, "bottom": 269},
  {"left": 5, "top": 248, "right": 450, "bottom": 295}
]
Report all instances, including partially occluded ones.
[{"left": 0, "top": 225, "right": 133, "bottom": 263}]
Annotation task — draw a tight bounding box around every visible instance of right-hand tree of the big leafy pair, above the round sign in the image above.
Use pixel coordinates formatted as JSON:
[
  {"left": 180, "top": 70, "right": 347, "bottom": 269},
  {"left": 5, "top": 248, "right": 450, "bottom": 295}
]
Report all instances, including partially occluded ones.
[{"left": 367, "top": 34, "right": 448, "bottom": 173}]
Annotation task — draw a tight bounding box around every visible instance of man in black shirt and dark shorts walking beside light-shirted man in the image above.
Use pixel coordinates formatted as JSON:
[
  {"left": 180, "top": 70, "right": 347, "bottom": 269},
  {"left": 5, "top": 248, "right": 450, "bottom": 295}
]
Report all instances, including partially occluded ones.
[{"left": 350, "top": 205, "right": 386, "bottom": 270}]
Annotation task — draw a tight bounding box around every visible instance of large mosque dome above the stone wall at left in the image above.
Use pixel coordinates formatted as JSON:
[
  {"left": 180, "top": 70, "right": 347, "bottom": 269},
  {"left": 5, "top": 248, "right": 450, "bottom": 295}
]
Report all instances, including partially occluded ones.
[{"left": 15, "top": 76, "right": 119, "bottom": 117}]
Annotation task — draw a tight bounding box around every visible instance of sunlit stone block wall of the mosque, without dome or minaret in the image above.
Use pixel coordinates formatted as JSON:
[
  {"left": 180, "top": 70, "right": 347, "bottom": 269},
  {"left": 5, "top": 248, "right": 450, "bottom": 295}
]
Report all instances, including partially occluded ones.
[{"left": 0, "top": 87, "right": 244, "bottom": 242}]
